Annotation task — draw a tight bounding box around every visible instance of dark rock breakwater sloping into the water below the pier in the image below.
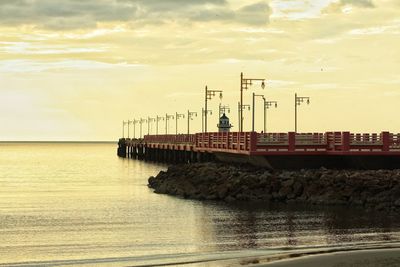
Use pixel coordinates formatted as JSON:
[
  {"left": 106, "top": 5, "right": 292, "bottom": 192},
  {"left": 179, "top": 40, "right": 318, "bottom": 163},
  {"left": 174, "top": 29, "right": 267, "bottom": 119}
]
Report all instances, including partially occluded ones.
[{"left": 148, "top": 163, "right": 400, "bottom": 212}]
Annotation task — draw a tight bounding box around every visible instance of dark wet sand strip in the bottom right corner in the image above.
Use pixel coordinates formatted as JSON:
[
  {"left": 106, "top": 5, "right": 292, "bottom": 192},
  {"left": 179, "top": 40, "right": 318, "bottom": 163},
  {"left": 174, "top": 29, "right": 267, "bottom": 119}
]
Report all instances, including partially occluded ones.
[{"left": 258, "top": 248, "right": 400, "bottom": 267}]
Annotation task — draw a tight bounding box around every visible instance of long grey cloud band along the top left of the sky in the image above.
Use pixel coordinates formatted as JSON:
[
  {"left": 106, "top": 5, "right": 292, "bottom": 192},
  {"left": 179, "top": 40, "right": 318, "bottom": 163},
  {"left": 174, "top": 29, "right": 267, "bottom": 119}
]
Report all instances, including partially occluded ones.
[{"left": 0, "top": 0, "right": 271, "bottom": 30}]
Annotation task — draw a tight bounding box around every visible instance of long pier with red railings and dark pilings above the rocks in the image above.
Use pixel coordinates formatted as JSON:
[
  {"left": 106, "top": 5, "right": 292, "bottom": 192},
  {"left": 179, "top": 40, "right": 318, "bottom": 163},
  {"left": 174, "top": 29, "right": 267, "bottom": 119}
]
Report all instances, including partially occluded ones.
[{"left": 118, "top": 132, "right": 400, "bottom": 169}]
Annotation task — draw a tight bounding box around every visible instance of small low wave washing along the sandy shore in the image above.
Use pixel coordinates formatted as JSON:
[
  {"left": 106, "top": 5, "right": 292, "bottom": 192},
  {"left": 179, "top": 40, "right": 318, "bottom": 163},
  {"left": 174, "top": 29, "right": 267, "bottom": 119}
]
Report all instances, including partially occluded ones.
[{"left": 0, "top": 242, "right": 400, "bottom": 267}]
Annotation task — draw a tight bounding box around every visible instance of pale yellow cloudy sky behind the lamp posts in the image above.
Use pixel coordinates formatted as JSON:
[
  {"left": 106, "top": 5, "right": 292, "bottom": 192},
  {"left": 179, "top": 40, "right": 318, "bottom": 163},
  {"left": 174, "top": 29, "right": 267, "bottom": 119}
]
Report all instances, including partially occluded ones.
[{"left": 0, "top": 0, "right": 400, "bottom": 141}]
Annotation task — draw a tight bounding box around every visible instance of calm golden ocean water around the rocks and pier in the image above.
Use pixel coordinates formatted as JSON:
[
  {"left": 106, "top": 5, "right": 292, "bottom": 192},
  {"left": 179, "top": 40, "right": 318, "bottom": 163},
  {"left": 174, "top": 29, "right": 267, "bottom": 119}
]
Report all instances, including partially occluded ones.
[{"left": 0, "top": 143, "right": 400, "bottom": 266}]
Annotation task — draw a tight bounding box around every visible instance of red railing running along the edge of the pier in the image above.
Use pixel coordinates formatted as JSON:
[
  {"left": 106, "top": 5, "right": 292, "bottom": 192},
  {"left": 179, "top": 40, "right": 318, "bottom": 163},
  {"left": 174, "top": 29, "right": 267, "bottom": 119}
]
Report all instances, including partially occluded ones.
[{"left": 143, "top": 132, "right": 400, "bottom": 154}]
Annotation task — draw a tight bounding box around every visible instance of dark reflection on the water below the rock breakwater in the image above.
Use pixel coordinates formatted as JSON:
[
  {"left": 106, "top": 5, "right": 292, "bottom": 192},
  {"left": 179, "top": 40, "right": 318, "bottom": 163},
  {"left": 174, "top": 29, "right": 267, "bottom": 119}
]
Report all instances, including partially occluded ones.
[{"left": 195, "top": 202, "right": 400, "bottom": 253}]
